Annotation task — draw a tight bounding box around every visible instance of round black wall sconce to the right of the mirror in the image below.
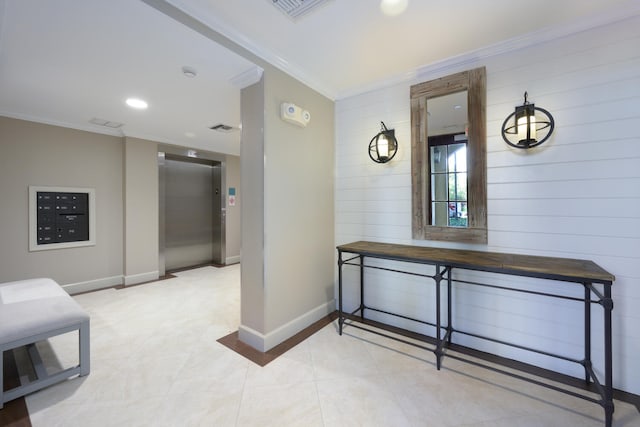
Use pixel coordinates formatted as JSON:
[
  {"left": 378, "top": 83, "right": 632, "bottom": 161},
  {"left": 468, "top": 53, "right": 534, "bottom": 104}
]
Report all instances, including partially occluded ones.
[{"left": 502, "top": 92, "right": 554, "bottom": 148}]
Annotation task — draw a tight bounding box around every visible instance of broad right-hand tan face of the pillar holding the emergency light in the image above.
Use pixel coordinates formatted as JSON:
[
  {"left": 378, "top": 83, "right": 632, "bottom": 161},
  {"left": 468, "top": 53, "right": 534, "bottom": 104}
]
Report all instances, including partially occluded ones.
[{"left": 264, "top": 70, "right": 335, "bottom": 331}]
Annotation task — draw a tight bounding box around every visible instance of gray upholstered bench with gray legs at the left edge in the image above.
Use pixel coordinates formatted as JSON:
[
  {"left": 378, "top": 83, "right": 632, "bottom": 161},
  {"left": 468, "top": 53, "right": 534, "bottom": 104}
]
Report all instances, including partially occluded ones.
[{"left": 0, "top": 279, "right": 90, "bottom": 408}]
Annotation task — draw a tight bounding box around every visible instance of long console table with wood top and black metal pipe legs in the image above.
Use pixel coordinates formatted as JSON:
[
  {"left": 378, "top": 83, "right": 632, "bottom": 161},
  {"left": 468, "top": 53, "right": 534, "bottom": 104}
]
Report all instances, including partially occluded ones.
[{"left": 337, "top": 241, "right": 615, "bottom": 427}]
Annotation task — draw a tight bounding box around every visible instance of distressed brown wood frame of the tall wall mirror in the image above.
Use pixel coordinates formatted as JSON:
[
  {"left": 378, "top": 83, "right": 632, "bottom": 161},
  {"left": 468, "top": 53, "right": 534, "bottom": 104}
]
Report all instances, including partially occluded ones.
[{"left": 411, "top": 67, "right": 487, "bottom": 243}]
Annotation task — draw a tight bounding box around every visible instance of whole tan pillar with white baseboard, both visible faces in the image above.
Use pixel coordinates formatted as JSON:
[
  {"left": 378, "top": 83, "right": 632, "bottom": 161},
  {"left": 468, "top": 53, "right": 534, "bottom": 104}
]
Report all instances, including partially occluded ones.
[{"left": 240, "top": 67, "right": 335, "bottom": 351}]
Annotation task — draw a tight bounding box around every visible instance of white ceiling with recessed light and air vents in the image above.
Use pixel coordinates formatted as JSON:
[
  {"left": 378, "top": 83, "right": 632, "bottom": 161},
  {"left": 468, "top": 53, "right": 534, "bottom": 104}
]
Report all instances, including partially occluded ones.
[{"left": 0, "top": 0, "right": 640, "bottom": 154}]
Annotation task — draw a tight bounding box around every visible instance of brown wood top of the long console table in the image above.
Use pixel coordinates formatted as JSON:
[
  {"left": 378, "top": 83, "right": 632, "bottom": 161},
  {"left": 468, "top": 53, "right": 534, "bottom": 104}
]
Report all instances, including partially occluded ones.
[{"left": 337, "top": 241, "right": 615, "bottom": 284}]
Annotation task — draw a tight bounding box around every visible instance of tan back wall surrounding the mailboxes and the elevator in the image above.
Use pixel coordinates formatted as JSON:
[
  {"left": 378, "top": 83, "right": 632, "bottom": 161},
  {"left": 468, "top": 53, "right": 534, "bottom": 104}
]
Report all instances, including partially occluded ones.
[{"left": 0, "top": 117, "right": 242, "bottom": 293}]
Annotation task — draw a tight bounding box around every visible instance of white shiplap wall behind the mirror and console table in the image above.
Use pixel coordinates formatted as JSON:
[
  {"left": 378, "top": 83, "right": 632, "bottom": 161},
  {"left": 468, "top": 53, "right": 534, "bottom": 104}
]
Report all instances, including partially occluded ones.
[{"left": 335, "top": 16, "right": 640, "bottom": 394}]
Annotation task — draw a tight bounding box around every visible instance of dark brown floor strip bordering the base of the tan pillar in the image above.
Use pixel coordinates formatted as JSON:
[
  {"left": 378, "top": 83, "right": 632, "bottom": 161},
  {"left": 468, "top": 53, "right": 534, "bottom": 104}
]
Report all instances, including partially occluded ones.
[{"left": 218, "top": 312, "right": 338, "bottom": 366}]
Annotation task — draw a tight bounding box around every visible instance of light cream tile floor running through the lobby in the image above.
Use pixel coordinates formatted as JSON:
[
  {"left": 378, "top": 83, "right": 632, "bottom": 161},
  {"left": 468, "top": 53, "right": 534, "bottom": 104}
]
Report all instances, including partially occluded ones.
[{"left": 21, "top": 265, "right": 640, "bottom": 427}]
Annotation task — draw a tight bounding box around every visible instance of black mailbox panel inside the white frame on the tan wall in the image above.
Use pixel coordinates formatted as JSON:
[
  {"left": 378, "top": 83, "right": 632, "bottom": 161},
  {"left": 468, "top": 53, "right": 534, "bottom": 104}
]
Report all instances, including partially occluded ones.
[{"left": 36, "top": 191, "right": 89, "bottom": 245}]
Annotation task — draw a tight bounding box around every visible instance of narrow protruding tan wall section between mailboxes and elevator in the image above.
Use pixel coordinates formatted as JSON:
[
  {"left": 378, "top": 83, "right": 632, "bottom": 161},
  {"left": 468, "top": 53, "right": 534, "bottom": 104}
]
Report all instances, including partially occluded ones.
[{"left": 124, "top": 138, "right": 159, "bottom": 285}]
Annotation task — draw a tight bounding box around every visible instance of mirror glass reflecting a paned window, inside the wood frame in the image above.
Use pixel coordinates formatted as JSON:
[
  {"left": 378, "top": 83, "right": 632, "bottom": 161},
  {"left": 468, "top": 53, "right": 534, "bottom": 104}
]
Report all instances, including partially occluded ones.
[{"left": 427, "top": 91, "right": 468, "bottom": 227}]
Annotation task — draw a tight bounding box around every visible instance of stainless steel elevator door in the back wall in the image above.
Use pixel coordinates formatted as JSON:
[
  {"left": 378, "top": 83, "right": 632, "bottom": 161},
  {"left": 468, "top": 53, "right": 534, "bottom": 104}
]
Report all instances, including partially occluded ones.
[{"left": 164, "top": 159, "right": 220, "bottom": 271}]
